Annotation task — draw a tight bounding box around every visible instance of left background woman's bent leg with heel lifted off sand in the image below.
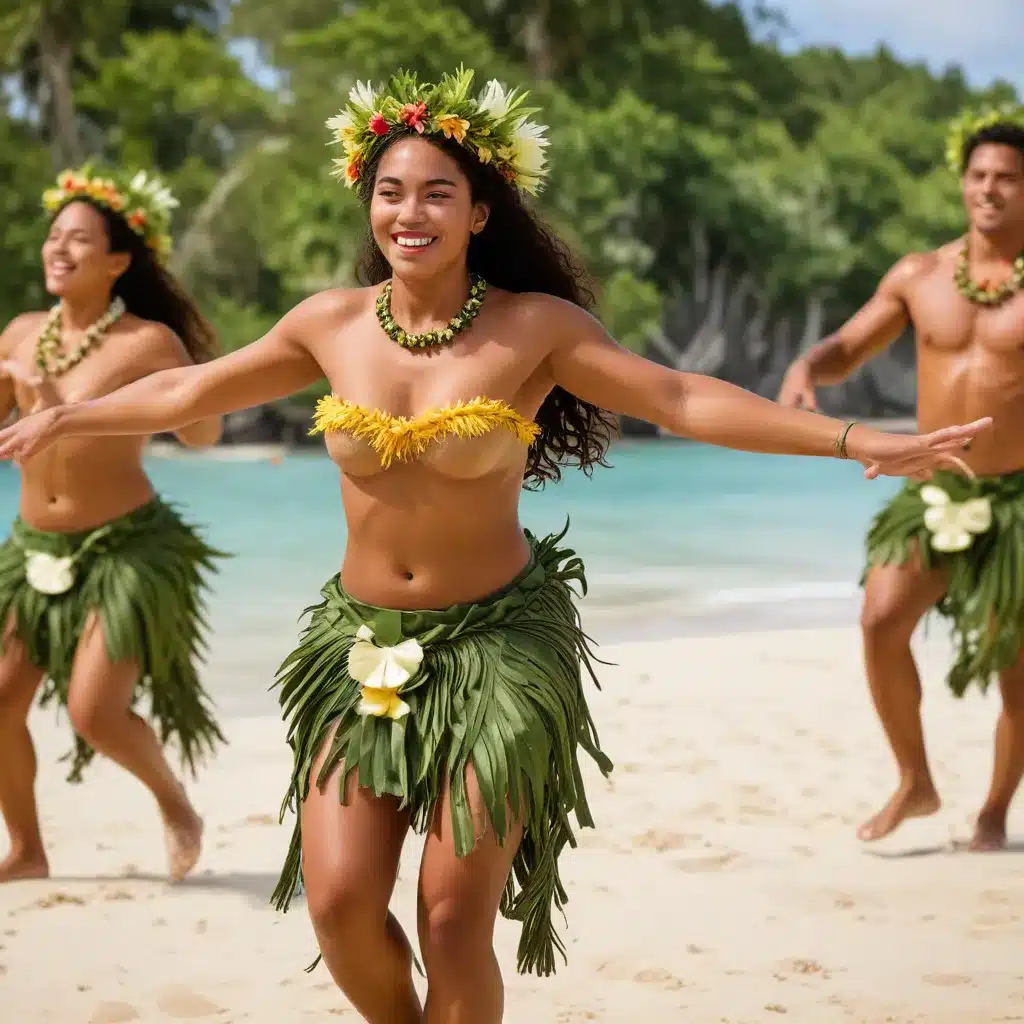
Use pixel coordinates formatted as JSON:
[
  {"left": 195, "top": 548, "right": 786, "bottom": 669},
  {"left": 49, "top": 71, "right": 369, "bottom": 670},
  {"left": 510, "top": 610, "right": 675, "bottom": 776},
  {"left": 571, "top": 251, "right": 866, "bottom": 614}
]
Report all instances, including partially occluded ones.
[{"left": 68, "top": 614, "right": 203, "bottom": 882}]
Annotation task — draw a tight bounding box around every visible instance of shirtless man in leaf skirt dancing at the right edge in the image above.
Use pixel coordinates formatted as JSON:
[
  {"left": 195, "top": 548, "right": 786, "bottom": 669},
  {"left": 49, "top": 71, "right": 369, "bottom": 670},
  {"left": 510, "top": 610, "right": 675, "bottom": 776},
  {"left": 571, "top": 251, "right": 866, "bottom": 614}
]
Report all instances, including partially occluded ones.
[{"left": 779, "top": 110, "right": 1024, "bottom": 851}]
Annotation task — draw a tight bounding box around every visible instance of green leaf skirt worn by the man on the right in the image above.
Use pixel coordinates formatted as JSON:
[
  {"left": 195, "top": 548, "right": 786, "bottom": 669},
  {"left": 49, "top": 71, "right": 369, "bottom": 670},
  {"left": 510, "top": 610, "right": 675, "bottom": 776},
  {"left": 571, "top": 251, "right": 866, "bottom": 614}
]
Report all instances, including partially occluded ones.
[{"left": 861, "top": 472, "right": 1024, "bottom": 696}]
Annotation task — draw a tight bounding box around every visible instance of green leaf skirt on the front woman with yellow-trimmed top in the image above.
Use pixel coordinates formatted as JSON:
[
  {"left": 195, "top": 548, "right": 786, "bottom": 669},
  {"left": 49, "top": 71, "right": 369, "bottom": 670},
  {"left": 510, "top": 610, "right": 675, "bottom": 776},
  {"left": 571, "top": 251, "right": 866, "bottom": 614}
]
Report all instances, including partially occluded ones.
[{"left": 273, "top": 530, "right": 612, "bottom": 975}]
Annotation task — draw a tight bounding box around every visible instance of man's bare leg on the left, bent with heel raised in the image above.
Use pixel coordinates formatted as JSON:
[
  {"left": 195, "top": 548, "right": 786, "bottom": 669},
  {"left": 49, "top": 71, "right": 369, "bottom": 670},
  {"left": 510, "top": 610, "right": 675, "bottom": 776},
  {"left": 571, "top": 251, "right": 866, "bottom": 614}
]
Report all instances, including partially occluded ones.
[{"left": 857, "top": 562, "right": 945, "bottom": 842}]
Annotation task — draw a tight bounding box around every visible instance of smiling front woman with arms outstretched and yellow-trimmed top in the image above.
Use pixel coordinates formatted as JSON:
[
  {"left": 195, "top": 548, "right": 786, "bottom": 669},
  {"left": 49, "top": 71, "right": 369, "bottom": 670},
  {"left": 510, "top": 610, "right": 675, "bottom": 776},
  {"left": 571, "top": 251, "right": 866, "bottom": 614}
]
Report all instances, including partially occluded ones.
[{"left": 0, "top": 72, "right": 986, "bottom": 1024}]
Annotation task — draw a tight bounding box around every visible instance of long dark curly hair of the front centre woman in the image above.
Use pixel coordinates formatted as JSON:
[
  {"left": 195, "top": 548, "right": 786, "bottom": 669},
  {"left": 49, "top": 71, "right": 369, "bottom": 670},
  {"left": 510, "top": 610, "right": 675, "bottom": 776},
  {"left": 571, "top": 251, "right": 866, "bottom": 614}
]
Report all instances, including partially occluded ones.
[{"left": 355, "top": 135, "right": 616, "bottom": 487}]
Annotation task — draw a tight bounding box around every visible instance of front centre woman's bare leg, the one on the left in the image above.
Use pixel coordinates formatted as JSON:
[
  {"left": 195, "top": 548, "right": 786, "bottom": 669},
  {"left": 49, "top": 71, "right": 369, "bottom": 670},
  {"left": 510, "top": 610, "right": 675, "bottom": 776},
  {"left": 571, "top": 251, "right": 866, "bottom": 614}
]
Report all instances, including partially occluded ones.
[{"left": 302, "top": 744, "right": 423, "bottom": 1024}]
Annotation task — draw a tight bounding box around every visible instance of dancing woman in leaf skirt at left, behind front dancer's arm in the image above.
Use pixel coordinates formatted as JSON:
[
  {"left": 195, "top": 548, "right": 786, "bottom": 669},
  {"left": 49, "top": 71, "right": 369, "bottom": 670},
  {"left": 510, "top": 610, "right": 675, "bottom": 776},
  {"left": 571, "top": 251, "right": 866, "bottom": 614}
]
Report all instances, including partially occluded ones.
[{"left": 0, "top": 165, "right": 222, "bottom": 882}]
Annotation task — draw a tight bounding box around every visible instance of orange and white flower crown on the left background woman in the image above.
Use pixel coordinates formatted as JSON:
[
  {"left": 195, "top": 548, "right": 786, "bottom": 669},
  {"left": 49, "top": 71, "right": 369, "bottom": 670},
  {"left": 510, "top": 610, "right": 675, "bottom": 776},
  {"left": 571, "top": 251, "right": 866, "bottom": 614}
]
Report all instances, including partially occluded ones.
[{"left": 43, "top": 167, "right": 178, "bottom": 262}]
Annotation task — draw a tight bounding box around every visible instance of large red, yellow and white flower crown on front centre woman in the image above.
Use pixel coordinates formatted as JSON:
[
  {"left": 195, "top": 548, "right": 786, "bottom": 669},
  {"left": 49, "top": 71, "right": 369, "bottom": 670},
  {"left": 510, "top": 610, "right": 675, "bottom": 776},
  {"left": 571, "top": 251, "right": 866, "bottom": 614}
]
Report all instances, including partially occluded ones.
[{"left": 327, "top": 68, "right": 548, "bottom": 195}]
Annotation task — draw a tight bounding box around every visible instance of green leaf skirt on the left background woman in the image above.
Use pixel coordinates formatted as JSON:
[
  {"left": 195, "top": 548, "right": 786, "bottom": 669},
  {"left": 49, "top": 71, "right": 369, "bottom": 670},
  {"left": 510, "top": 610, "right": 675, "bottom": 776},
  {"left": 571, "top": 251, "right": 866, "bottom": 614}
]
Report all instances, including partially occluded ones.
[{"left": 0, "top": 499, "right": 226, "bottom": 782}]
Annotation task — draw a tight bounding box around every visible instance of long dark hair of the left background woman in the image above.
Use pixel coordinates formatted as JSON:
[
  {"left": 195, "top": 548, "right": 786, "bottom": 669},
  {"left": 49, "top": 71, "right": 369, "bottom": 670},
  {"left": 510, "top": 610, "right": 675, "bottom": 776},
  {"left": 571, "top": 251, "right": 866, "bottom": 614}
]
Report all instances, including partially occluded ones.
[{"left": 58, "top": 197, "right": 219, "bottom": 362}]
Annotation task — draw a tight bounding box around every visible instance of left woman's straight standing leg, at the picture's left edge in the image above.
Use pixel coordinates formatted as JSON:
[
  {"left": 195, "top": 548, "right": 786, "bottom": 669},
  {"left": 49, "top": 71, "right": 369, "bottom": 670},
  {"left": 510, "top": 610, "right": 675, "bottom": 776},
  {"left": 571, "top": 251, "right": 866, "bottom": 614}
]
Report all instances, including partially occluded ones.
[{"left": 0, "top": 629, "right": 49, "bottom": 882}]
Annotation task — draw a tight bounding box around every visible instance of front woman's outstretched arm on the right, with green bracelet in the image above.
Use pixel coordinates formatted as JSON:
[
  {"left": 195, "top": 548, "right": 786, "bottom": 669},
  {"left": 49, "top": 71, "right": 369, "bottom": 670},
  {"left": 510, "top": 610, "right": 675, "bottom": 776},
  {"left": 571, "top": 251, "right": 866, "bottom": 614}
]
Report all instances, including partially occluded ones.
[{"left": 545, "top": 292, "right": 991, "bottom": 476}]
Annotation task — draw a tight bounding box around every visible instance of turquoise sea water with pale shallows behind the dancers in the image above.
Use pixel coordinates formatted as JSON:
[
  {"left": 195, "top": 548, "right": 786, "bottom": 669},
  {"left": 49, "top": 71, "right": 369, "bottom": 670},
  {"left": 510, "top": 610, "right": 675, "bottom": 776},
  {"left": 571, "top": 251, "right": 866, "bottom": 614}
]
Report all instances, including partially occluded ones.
[{"left": 0, "top": 441, "right": 899, "bottom": 710}]
